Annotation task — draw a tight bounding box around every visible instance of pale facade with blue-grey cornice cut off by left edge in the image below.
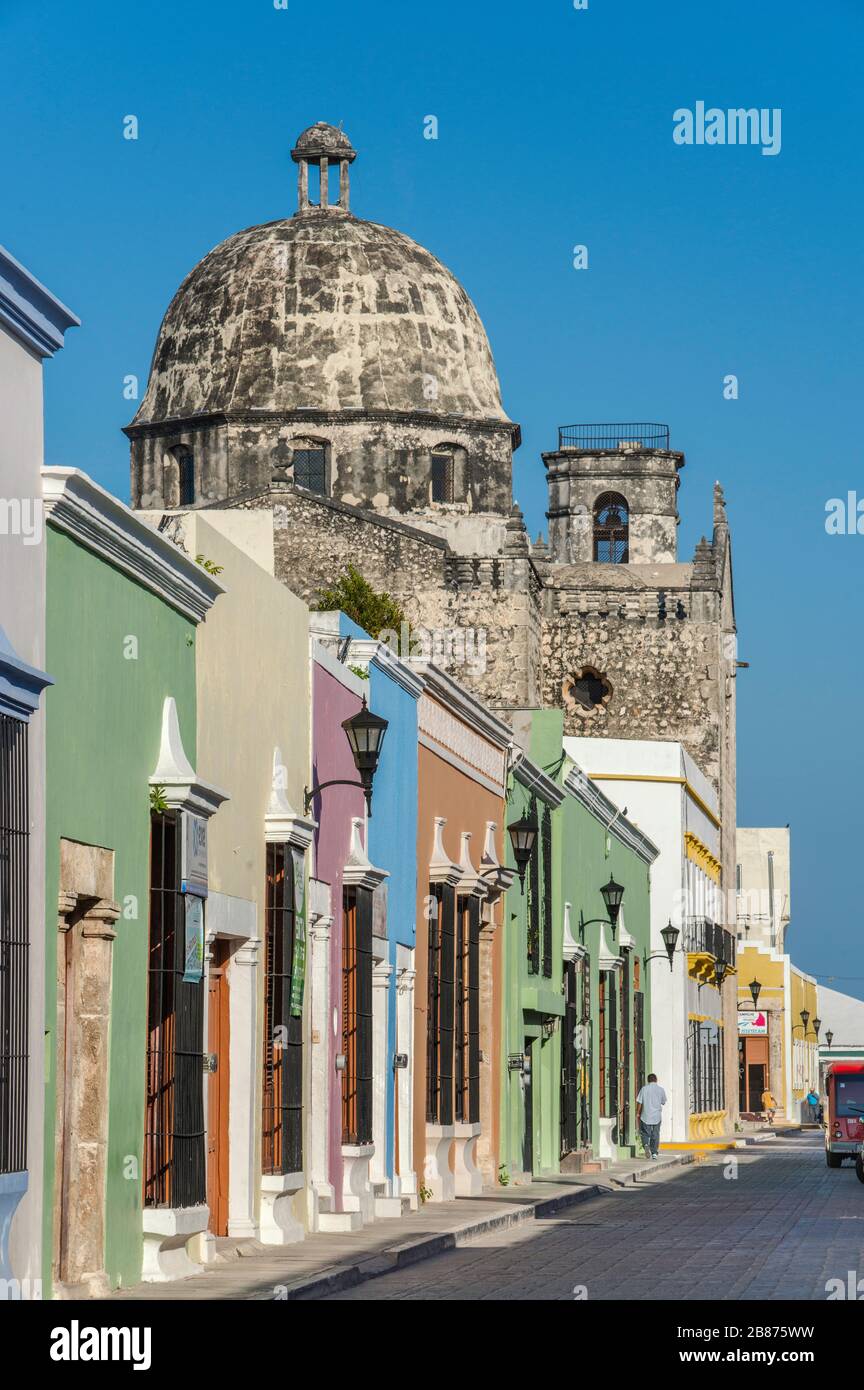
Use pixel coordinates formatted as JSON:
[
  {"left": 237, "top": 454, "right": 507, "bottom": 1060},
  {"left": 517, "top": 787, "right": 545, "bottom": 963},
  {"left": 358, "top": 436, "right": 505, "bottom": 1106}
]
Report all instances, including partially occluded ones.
[{"left": 0, "top": 246, "right": 78, "bottom": 1298}]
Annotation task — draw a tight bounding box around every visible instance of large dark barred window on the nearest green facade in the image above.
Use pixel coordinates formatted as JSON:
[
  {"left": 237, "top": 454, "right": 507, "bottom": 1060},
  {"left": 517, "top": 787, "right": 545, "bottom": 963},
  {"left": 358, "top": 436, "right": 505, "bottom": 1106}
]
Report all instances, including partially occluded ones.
[{"left": 144, "top": 813, "right": 207, "bottom": 1207}]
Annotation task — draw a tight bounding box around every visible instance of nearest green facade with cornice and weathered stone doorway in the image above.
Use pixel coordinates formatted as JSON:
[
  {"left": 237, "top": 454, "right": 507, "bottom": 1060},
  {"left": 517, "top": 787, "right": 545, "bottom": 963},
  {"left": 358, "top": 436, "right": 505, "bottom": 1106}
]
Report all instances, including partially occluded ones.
[{"left": 43, "top": 468, "right": 221, "bottom": 1297}]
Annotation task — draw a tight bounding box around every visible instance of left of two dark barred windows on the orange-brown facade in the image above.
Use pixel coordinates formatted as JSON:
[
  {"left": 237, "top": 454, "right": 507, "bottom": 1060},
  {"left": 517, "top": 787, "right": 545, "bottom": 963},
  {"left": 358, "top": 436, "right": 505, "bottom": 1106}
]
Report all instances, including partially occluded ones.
[{"left": 426, "top": 883, "right": 458, "bottom": 1125}]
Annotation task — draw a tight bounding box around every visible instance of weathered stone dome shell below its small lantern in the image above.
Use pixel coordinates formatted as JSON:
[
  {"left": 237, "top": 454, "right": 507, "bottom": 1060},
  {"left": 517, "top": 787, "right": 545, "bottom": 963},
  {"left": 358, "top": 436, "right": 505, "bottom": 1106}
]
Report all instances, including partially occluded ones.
[{"left": 133, "top": 211, "right": 507, "bottom": 425}]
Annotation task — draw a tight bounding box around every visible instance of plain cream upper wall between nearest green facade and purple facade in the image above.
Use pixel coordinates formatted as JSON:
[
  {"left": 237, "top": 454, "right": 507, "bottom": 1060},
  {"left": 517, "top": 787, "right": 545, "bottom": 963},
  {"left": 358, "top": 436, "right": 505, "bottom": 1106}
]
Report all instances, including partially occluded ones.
[{"left": 183, "top": 513, "right": 310, "bottom": 900}]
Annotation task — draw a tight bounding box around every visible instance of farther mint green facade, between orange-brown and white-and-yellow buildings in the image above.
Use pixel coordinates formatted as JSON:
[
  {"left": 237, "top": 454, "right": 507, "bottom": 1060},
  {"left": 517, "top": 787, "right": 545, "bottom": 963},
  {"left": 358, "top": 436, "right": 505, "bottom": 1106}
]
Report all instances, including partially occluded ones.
[{"left": 499, "top": 710, "right": 657, "bottom": 1182}]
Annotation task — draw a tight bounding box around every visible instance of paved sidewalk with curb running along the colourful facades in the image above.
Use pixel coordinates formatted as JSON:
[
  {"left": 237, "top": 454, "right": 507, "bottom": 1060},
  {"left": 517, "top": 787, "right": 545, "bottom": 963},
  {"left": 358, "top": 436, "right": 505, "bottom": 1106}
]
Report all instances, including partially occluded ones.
[{"left": 110, "top": 1154, "right": 695, "bottom": 1301}]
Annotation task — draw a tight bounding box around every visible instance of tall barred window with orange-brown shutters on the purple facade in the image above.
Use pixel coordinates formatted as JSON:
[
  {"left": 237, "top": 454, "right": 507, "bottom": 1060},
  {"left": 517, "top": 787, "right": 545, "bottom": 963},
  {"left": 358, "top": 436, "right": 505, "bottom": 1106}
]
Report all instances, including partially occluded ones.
[{"left": 342, "top": 888, "right": 372, "bottom": 1144}]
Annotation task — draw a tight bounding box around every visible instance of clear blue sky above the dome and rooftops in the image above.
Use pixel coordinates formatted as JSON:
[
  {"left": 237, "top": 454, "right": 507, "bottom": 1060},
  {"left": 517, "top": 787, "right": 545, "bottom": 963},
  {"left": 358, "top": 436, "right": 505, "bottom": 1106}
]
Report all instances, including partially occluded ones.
[{"left": 0, "top": 0, "right": 864, "bottom": 997}]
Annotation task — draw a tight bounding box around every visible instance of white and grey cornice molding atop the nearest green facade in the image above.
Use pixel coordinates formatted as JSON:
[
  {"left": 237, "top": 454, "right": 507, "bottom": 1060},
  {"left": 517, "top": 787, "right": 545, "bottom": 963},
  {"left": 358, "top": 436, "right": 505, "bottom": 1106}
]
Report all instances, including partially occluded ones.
[{"left": 42, "top": 468, "right": 225, "bottom": 623}]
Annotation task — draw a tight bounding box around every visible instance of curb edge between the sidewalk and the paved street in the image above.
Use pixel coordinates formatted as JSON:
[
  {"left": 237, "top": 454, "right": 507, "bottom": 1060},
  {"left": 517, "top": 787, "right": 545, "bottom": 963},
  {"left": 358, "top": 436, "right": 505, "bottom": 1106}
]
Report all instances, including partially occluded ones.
[{"left": 270, "top": 1154, "right": 693, "bottom": 1302}]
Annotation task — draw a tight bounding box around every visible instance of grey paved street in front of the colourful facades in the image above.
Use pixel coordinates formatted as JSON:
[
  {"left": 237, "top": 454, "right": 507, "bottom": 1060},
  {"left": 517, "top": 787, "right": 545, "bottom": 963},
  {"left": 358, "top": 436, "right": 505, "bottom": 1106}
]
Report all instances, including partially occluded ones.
[{"left": 323, "top": 1133, "right": 864, "bottom": 1300}]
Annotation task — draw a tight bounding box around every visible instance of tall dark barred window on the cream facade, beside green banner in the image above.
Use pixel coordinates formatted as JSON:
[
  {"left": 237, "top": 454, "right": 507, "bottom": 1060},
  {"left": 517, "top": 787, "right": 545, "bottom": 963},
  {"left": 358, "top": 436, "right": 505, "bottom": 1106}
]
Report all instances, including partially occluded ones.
[{"left": 261, "top": 844, "right": 303, "bottom": 1173}]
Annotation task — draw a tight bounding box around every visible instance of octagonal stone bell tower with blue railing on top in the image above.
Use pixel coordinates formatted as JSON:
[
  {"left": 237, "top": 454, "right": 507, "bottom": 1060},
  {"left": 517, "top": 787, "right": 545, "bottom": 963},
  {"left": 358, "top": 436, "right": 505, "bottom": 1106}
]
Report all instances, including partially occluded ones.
[{"left": 543, "top": 424, "right": 685, "bottom": 564}]
